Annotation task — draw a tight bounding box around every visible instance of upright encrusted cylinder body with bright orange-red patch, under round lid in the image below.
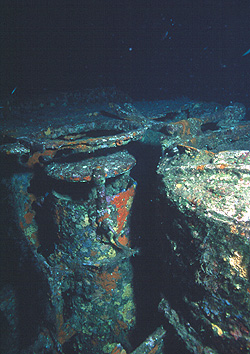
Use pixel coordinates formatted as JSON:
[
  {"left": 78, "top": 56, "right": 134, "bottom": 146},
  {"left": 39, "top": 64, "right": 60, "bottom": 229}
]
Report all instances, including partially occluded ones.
[{"left": 45, "top": 153, "right": 136, "bottom": 353}]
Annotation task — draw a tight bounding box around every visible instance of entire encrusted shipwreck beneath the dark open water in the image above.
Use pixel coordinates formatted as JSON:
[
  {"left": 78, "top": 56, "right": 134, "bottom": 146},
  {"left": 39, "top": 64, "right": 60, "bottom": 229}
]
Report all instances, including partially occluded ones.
[{"left": 0, "top": 90, "right": 250, "bottom": 354}]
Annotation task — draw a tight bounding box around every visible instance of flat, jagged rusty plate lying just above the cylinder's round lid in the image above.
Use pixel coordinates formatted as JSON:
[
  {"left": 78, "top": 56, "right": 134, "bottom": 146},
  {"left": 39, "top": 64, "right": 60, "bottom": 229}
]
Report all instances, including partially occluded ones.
[{"left": 1, "top": 119, "right": 145, "bottom": 167}]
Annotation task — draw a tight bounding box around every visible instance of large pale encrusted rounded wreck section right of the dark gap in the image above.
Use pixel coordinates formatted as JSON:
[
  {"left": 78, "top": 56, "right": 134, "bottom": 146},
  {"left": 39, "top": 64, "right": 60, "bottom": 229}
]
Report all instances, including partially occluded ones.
[{"left": 158, "top": 146, "right": 250, "bottom": 354}]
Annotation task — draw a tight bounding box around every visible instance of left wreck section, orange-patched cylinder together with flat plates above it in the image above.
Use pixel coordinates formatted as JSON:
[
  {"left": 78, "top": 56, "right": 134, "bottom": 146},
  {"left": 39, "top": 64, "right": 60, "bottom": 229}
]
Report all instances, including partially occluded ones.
[{"left": 1, "top": 96, "right": 152, "bottom": 353}]
